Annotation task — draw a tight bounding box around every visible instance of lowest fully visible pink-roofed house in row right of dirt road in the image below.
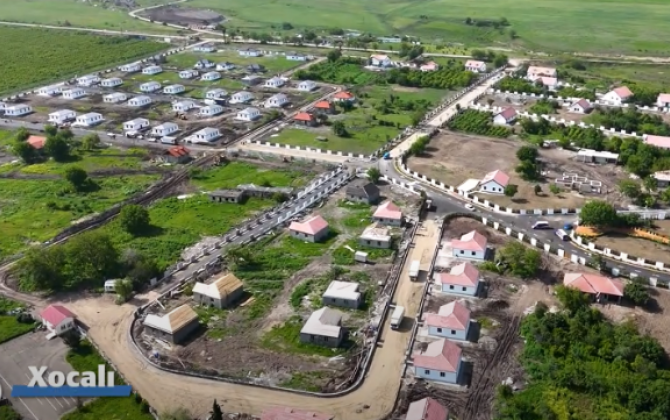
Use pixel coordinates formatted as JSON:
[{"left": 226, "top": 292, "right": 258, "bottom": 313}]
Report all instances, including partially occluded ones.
[{"left": 413, "top": 338, "right": 462, "bottom": 384}]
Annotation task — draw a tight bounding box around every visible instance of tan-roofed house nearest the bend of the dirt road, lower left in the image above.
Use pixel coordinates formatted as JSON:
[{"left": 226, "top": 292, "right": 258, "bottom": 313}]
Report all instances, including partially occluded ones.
[{"left": 142, "top": 304, "right": 200, "bottom": 344}]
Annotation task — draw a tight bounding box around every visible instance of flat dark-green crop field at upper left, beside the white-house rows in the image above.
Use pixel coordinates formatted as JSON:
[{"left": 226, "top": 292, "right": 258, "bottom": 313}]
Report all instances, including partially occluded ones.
[{"left": 0, "top": 27, "right": 167, "bottom": 94}]
